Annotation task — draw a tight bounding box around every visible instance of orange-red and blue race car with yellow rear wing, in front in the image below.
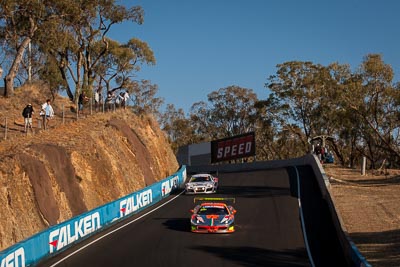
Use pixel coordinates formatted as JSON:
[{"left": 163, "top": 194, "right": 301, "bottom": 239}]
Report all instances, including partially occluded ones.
[{"left": 190, "top": 198, "right": 236, "bottom": 233}]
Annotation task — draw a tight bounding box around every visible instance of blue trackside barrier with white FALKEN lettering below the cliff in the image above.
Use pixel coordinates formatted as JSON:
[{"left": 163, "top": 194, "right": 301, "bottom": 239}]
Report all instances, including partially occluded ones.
[{"left": 0, "top": 166, "right": 186, "bottom": 267}]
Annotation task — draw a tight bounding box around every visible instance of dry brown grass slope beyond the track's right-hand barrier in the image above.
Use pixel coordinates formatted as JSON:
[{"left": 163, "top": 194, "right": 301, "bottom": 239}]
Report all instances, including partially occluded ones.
[{"left": 324, "top": 165, "right": 400, "bottom": 267}]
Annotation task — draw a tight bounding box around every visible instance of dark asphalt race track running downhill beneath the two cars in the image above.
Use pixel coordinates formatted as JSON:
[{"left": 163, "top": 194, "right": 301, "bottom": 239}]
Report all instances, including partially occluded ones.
[{"left": 39, "top": 166, "right": 347, "bottom": 267}]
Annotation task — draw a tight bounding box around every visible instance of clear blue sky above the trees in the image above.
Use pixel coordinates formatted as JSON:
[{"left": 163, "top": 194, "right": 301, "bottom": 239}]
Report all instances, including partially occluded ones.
[{"left": 111, "top": 0, "right": 400, "bottom": 113}]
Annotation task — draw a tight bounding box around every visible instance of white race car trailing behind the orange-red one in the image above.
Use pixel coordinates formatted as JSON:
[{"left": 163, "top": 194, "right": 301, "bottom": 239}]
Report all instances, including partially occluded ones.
[{"left": 186, "top": 173, "right": 218, "bottom": 194}]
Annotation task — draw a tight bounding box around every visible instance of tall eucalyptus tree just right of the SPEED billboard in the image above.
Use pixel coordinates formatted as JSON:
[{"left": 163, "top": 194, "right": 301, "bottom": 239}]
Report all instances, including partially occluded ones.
[{"left": 266, "top": 61, "right": 330, "bottom": 151}]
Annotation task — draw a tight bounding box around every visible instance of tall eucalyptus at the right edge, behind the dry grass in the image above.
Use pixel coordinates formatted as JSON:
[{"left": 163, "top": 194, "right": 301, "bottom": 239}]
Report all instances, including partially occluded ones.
[{"left": 342, "top": 54, "right": 400, "bottom": 167}]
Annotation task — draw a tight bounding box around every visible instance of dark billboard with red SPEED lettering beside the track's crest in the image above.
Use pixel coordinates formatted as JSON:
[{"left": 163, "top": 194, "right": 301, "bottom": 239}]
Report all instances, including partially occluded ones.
[{"left": 211, "top": 132, "right": 256, "bottom": 163}]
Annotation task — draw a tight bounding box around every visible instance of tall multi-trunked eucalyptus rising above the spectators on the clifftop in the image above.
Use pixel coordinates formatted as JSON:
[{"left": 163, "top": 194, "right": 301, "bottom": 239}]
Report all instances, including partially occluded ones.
[{"left": 36, "top": 0, "right": 143, "bottom": 100}]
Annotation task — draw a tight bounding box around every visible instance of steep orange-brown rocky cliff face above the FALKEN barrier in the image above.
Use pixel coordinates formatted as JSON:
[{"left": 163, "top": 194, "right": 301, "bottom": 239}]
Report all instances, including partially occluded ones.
[{"left": 0, "top": 110, "right": 179, "bottom": 250}]
